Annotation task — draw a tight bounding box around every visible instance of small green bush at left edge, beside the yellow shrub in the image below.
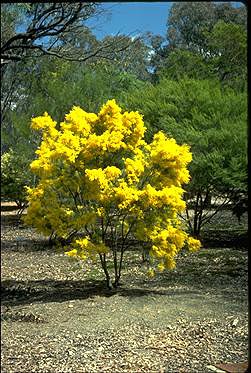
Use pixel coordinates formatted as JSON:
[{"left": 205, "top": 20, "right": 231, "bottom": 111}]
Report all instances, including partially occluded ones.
[{"left": 1, "top": 149, "right": 34, "bottom": 208}]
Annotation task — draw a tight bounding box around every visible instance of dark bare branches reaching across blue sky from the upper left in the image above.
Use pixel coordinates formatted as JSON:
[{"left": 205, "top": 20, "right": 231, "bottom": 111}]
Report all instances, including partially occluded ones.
[{"left": 1, "top": 3, "right": 139, "bottom": 73}]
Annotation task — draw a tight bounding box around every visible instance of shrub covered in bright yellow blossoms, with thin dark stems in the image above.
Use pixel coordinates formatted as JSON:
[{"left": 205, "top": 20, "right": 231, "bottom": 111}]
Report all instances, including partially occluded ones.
[{"left": 26, "top": 100, "right": 200, "bottom": 287}]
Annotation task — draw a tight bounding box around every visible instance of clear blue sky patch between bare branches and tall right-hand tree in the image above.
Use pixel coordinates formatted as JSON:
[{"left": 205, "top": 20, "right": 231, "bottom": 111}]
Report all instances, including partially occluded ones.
[{"left": 87, "top": 1, "right": 172, "bottom": 39}]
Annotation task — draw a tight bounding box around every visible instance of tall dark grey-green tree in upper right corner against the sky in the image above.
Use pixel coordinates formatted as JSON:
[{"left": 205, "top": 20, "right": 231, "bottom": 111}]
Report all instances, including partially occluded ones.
[{"left": 149, "top": 2, "right": 247, "bottom": 83}]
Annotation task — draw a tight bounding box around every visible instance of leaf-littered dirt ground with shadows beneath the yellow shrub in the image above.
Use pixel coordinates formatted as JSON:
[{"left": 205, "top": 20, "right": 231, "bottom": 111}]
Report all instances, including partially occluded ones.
[{"left": 1, "top": 204, "right": 248, "bottom": 373}]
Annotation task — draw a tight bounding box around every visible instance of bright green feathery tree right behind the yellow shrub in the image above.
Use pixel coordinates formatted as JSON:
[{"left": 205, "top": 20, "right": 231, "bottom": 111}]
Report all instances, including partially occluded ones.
[{"left": 122, "top": 79, "right": 247, "bottom": 235}]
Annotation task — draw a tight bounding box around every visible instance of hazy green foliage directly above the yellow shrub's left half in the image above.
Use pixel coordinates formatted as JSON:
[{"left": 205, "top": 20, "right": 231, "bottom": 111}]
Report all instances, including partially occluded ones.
[{"left": 2, "top": 58, "right": 142, "bottom": 153}]
